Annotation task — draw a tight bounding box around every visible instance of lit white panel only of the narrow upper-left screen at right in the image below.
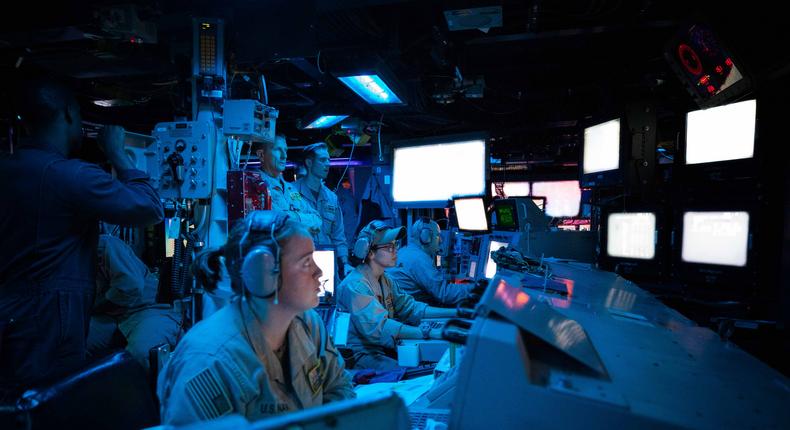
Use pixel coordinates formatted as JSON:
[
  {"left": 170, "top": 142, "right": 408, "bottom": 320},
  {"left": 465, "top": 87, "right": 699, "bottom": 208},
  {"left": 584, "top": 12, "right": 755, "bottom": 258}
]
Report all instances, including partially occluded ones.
[{"left": 582, "top": 119, "right": 620, "bottom": 173}]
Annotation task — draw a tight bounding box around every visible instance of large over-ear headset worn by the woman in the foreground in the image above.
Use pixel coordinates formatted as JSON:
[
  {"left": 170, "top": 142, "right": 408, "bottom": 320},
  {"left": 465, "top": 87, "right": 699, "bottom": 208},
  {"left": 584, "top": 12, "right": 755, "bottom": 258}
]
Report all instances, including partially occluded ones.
[{"left": 239, "top": 211, "right": 288, "bottom": 304}]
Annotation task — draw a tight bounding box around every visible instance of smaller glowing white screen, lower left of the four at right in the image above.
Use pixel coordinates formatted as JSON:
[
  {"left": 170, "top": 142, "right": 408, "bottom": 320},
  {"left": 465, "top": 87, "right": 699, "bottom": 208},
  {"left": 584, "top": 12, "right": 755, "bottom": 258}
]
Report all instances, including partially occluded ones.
[{"left": 606, "top": 212, "right": 656, "bottom": 260}]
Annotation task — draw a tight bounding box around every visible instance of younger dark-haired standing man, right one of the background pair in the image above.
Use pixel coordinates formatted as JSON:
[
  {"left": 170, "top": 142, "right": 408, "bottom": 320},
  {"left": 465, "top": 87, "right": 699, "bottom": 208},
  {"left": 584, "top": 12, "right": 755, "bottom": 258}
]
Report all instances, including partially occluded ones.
[{"left": 294, "top": 142, "right": 354, "bottom": 275}]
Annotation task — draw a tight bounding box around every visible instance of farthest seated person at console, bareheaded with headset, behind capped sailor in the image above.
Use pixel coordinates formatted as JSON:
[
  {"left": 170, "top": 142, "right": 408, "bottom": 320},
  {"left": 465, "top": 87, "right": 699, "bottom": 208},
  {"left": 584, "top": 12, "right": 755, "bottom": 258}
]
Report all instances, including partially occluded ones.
[{"left": 386, "top": 217, "right": 474, "bottom": 306}]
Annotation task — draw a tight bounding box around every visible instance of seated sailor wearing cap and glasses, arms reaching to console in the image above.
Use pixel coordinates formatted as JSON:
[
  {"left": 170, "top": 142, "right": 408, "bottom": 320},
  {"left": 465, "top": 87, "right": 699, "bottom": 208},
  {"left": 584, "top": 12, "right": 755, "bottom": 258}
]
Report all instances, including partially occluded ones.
[{"left": 337, "top": 221, "right": 456, "bottom": 370}]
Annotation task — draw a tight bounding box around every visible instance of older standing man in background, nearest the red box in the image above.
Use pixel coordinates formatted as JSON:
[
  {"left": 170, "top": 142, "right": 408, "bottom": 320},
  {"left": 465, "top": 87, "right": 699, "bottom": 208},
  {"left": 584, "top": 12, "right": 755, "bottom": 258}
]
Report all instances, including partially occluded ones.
[{"left": 256, "top": 134, "right": 321, "bottom": 235}]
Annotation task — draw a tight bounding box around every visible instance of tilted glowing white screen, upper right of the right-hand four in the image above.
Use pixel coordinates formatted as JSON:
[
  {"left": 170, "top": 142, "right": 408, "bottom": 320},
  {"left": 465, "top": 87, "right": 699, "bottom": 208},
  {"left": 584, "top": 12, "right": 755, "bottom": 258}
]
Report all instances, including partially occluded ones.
[{"left": 686, "top": 100, "right": 757, "bottom": 164}]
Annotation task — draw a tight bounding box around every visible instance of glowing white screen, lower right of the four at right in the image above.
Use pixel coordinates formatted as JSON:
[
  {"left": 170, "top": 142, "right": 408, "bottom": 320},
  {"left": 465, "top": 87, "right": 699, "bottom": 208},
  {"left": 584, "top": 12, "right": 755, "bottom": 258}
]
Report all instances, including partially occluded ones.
[{"left": 681, "top": 212, "right": 749, "bottom": 267}]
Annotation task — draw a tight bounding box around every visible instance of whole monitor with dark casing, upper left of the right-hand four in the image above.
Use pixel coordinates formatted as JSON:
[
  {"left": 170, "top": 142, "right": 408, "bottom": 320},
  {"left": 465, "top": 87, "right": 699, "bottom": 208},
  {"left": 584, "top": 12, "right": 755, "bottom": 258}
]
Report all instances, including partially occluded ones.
[{"left": 580, "top": 118, "right": 622, "bottom": 186}]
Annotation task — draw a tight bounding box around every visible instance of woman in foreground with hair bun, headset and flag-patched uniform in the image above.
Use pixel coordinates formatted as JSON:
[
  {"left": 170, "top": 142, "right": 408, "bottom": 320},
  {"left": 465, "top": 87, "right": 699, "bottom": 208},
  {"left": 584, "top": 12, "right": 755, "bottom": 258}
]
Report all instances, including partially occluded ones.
[{"left": 157, "top": 211, "right": 355, "bottom": 424}]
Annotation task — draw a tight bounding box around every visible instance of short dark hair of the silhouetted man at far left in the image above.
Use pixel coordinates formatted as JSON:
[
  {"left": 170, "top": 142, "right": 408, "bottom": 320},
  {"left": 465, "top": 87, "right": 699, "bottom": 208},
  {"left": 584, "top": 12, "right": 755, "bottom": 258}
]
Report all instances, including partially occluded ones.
[{"left": 11, "top": 78, "right": 79, "bottom": 129}]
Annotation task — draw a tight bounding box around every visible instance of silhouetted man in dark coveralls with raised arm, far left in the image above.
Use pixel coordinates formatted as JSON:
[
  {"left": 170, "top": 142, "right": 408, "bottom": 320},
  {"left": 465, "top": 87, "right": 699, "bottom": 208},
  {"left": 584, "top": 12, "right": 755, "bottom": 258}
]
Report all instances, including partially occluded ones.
[{"left": 0, "top": 77, "right": 163, "bottom": 389}]
